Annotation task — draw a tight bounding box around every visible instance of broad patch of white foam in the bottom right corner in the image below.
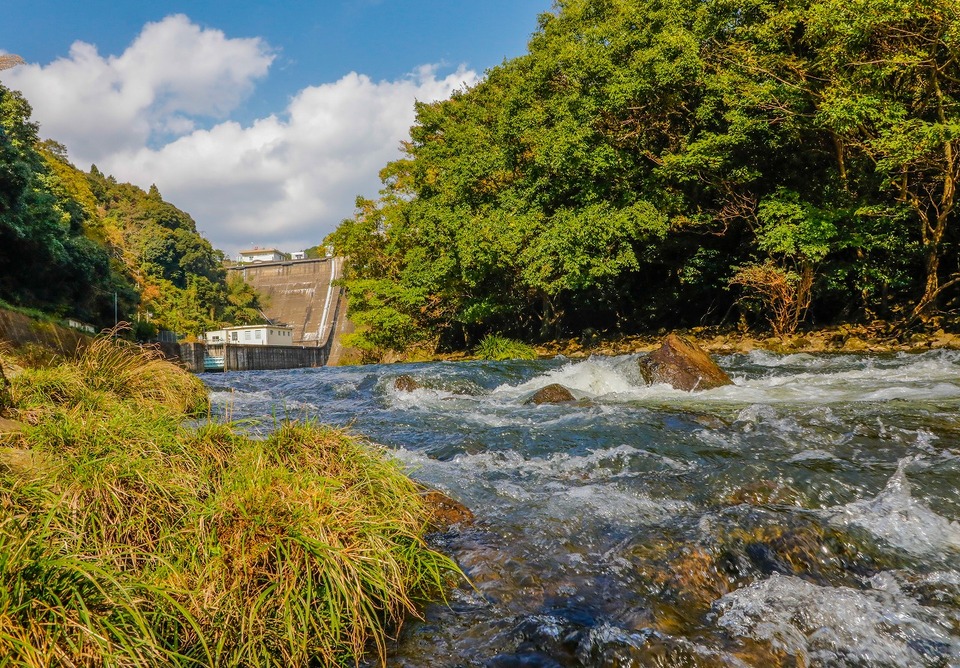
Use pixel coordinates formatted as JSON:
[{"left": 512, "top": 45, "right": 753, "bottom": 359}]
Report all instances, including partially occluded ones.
[{"left": 714, "top": 574, "right": 960, "bottom": 668}]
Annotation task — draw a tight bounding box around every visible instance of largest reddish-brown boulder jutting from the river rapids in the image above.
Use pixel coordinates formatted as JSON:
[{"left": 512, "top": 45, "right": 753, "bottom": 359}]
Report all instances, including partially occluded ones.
[{"left": 640, "top": 334, "right": 733, "bottom": 392}]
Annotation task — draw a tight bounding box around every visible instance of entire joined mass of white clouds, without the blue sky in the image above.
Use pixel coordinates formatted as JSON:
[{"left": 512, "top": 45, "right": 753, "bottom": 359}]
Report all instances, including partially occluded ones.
[{"left": 4, "top": 15, "right": 478, "bottom": 254}]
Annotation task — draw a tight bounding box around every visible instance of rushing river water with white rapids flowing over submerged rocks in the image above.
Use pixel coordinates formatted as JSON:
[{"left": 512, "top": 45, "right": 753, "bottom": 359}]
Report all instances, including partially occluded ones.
[{"left": 204, "top": 351, "right": 960, "bottom": 668}]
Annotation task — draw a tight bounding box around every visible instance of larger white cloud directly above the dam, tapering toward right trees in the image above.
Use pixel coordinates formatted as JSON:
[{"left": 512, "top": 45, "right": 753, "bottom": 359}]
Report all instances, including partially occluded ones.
[{"left": 117, "top": 67, "right": 477, "bottom": 253}]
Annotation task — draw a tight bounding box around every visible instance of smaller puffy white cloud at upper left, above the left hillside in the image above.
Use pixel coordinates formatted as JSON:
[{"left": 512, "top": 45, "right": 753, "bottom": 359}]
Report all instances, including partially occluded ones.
[{"left": 4, "top": 14, "right": 274, "bottom": 165}]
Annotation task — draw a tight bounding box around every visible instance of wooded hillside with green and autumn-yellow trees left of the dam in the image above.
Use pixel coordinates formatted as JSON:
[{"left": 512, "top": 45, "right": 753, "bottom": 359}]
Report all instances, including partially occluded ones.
[{"left": 0, "top": 86, "right": 262, "bottom": 338}]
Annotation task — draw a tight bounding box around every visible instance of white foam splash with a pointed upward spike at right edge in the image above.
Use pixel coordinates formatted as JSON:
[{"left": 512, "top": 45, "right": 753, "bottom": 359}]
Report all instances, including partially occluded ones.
[{"left": 821, "top": 457, "right": 960, "bottom": 557}]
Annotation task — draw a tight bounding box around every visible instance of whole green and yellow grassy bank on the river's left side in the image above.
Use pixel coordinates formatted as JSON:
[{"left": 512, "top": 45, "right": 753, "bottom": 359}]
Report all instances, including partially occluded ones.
[{"left": 0, "top": 338, "right": 459, "bottom": 666}]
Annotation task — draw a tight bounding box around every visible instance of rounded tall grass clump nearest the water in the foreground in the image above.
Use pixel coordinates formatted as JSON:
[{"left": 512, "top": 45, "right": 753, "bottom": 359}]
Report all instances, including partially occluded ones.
[{"left": 196, "top": 423, "right": 452, "bottom": 666}]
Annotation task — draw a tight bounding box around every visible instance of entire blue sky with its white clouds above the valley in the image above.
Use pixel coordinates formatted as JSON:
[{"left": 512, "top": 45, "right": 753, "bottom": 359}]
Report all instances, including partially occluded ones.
[{"left": 0, "top": 0, "right": 552, "bottom": 254}]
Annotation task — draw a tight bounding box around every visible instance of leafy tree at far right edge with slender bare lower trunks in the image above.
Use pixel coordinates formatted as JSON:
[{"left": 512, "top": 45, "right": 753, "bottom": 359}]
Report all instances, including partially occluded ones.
[{"left": 807, "top": 0, "right": 960, "bottom": 317}]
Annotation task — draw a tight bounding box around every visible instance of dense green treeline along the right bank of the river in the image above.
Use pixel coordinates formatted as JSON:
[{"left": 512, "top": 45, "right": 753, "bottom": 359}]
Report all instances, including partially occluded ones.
[{"left": 328, "top": 0, "right": 960, "bottom": 358}]
